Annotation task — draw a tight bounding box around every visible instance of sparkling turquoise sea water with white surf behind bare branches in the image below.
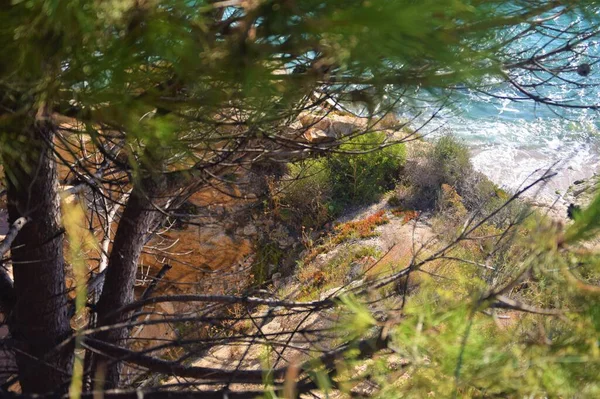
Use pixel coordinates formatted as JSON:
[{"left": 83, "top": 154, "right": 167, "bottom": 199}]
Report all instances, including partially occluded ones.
[{"left": 426, "top": 12, "right": 600, "bottom": 202}]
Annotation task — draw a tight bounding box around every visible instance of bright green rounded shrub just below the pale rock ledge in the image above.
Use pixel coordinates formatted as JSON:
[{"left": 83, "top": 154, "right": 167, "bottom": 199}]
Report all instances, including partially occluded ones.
[{"left": 324, "top": 132, "right": 406, "bottom": 204}]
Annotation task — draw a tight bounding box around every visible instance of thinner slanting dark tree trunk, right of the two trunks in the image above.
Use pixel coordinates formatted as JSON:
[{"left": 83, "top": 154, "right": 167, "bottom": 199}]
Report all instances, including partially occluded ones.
[{"left": 92, "top": 177, "right": 164, "bottom": 390}]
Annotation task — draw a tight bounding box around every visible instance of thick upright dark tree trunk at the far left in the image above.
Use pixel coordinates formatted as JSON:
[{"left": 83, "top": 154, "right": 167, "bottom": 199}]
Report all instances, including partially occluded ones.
[{"left": 3, "top": 118, "right": 73, "bottom": 393}]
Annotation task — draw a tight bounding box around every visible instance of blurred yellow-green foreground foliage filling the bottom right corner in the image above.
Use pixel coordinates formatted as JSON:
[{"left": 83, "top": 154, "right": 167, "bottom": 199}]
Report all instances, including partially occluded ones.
[{"left": 324, "top": 200, "right": 600, "bottom": 398}]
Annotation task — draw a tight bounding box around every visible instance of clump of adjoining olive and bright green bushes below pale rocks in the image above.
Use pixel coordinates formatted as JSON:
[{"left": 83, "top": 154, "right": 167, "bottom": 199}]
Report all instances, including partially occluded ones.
[{"left": 276, "top": 132, "right": 406, "bottom": 229}]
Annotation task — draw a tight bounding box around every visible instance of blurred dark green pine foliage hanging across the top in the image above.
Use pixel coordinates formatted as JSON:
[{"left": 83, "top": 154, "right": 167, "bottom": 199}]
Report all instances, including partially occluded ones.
[{"left": 0, "top": 0, "right": 564, "bottom": 177}]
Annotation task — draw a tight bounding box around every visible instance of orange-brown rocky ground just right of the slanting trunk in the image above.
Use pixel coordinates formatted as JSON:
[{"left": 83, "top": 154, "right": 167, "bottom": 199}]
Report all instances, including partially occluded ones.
[{"left": 140, "top": 188, "right": 257, "bottom": 294}]
